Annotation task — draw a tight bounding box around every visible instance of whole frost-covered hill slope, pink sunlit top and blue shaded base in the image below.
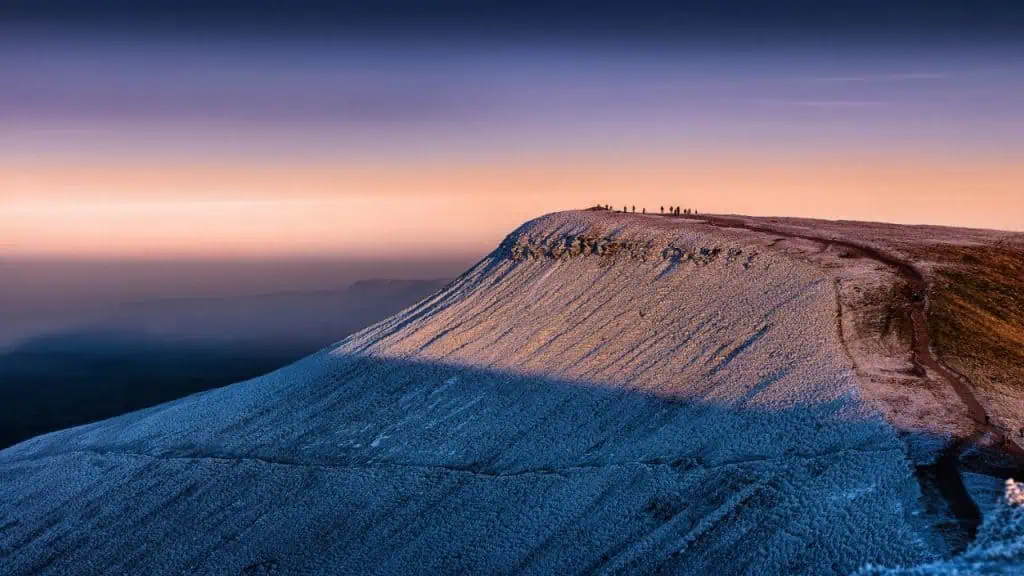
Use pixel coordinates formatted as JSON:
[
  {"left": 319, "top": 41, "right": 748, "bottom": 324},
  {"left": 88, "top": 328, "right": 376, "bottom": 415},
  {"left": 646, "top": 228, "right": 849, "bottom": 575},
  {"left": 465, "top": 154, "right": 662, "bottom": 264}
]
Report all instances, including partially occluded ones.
[{"left": 0, "top": 212, "right": 948, "bottom": 574}]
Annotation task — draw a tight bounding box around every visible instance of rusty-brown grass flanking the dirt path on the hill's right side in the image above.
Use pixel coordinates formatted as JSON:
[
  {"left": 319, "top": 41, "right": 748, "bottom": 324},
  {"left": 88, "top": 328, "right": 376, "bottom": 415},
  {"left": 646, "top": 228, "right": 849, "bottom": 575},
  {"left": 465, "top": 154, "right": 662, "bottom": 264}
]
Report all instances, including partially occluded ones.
[{"left": 704, "top": 217, "right": 1024, "bottom": 434}]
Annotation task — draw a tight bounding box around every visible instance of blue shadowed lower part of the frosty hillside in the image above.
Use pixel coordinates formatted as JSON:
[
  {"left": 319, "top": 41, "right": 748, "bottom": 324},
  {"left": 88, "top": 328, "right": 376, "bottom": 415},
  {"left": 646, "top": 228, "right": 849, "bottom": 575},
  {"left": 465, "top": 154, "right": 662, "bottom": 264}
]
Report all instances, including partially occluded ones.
[{"left": 0, "top": 351, "right": 991, "bottom": 573}]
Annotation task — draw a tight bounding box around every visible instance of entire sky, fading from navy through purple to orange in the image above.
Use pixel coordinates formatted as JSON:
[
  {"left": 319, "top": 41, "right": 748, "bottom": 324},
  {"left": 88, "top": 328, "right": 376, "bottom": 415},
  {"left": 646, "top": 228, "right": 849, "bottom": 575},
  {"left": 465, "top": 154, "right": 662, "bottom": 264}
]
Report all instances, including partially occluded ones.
[{"left": 0, "top": 0, "right": 1024, "bottom": 258}]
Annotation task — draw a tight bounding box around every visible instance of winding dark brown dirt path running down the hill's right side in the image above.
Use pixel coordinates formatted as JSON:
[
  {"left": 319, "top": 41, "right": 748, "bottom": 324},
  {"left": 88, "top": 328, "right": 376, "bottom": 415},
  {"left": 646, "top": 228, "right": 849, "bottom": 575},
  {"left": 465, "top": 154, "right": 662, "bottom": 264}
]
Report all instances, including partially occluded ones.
[{"left": 667, "top": 214, "right": 1004, "bottom": 540}]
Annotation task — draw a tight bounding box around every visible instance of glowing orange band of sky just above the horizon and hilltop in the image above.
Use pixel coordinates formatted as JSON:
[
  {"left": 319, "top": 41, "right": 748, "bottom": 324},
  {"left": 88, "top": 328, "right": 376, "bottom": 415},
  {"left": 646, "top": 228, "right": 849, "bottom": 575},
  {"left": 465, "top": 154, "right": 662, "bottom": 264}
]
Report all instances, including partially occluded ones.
[{"left": 0, "top": 155, "right": 1024, "bottom": 257}]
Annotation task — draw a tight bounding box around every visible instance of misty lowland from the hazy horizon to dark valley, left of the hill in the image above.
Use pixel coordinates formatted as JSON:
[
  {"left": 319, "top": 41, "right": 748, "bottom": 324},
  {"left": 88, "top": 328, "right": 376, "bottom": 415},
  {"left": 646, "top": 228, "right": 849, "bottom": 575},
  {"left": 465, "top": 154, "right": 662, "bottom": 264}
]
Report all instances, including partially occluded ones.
[{"left": 0, "top": 258, "right": 466, "bottom": 448}]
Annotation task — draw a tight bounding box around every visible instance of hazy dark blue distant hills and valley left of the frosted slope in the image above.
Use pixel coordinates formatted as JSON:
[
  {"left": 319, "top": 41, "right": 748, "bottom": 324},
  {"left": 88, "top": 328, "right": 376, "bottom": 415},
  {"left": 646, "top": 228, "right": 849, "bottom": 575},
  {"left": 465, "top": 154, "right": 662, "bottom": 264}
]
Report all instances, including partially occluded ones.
[{"left": 0, "top": 280, "right": 447, "bottom": 448}]
